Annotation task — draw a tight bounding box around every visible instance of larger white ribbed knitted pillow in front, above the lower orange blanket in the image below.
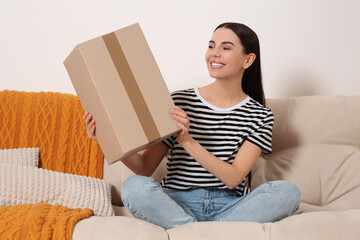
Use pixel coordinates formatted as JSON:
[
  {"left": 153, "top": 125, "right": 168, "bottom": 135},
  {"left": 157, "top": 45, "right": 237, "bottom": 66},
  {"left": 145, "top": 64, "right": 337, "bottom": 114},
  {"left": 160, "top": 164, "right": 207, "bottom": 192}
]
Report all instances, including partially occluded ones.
[{"left": 0, "top": 163, "right": 114, "bottom": 216}]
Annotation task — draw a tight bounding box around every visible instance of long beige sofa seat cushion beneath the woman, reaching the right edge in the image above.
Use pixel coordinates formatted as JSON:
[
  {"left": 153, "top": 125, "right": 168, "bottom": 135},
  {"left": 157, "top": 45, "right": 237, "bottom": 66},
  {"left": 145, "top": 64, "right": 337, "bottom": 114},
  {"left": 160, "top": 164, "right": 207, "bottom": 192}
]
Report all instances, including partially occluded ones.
[{"left": 168, "top": 209, "right": 360, "bottom": 240}]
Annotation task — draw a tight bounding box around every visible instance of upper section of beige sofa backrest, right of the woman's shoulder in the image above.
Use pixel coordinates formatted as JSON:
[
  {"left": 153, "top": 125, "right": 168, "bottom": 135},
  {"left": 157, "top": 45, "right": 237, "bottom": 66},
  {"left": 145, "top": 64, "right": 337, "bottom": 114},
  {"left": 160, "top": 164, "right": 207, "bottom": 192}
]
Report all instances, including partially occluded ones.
[{"left": 267, "top": 96, "right": 360, "bottom": 152}]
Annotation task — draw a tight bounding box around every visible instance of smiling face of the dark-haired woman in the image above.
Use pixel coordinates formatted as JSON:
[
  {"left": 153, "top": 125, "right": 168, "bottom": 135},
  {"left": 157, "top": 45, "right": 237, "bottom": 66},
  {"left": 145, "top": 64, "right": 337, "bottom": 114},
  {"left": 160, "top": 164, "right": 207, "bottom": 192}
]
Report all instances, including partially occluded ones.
[{"left": 205, "top": 28, "right": 249, "bottom": 79}]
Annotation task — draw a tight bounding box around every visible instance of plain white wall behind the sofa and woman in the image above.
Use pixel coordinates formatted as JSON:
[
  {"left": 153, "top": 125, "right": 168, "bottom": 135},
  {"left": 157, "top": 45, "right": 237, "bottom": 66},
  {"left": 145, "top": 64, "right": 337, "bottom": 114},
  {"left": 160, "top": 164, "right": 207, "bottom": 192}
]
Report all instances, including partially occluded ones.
[{"left": 0, "top": 0, "right": 360, "bottom": 98}]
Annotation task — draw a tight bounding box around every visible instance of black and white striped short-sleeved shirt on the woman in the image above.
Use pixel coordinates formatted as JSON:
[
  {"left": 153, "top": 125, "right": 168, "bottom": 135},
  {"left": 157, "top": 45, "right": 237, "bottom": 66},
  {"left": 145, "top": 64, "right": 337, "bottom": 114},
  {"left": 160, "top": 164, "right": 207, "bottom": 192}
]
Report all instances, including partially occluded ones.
[{"left": 162, "top": 88, "right": 274, "bottom": 195}]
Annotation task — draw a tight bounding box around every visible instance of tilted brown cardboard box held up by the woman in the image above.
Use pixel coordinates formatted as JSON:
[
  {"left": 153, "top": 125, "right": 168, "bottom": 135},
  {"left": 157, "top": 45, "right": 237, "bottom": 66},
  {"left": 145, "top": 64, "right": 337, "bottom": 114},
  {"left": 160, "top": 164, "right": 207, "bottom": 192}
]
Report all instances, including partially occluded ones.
[{"left": 64, "top": 24, "right": 179, "bottom": 164}]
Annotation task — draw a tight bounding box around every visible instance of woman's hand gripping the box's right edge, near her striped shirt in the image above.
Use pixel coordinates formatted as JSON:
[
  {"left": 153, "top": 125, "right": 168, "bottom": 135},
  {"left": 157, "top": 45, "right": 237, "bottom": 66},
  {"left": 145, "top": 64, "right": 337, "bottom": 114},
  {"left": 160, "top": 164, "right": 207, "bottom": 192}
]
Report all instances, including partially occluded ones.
[{"left": 170, "top": 107, "right": 192, "bottom": 145}]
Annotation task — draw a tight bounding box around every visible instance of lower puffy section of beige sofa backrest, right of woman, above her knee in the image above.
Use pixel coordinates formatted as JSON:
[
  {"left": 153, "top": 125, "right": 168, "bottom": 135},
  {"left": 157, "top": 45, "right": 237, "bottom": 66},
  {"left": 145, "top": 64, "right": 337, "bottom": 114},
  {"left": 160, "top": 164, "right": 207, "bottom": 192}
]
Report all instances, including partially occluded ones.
[{"left": 254, "top": 143, "right": 360, "bottom": 210}]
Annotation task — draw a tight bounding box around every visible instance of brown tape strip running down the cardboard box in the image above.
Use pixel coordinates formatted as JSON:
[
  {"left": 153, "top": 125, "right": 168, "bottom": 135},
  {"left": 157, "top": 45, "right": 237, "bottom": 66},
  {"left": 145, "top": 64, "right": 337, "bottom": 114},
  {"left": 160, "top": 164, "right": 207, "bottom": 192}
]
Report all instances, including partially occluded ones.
[{"left": 102, "top": 32, "right": 160, "bottom": 142}]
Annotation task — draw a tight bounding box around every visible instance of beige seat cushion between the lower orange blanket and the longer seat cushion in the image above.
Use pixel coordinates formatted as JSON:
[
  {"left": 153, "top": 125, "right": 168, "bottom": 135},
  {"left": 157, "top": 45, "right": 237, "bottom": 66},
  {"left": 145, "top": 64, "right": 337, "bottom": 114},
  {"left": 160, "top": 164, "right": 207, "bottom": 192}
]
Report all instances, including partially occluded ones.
[{"left": 72, "top": 216, "right": 168, "bottom": 240}]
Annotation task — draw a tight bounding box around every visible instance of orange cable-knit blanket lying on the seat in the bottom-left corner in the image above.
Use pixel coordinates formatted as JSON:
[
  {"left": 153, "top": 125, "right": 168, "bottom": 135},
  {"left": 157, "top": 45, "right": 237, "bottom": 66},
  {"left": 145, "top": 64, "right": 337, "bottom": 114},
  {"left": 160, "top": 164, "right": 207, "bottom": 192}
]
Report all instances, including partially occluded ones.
[{"left": 0, "top": 203, "right": 93, "bottom": 240}]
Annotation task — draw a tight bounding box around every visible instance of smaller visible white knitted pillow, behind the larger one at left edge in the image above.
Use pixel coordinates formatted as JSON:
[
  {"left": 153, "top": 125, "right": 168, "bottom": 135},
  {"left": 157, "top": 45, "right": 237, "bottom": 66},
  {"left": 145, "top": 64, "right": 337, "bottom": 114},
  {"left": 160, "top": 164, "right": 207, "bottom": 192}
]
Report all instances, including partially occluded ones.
[{"left": 0, "top": 148, "right": 39, "bottom": 167}]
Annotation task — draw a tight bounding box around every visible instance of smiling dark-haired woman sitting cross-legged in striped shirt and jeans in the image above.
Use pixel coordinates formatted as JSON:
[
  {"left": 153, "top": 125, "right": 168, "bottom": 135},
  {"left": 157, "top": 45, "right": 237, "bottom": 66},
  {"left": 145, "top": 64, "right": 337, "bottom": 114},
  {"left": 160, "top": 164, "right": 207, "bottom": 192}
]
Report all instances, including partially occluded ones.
[{"left": 84, "top": 23, "right": 300, "bottom": 229}]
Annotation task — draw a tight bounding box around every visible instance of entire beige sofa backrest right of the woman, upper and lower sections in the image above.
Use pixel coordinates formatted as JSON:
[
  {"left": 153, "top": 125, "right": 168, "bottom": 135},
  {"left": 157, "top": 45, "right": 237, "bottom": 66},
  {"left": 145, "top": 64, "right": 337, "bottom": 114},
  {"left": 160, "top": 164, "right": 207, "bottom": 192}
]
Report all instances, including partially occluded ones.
[{"left": 253, "top": 95, "right": 360, "bottom": 211}]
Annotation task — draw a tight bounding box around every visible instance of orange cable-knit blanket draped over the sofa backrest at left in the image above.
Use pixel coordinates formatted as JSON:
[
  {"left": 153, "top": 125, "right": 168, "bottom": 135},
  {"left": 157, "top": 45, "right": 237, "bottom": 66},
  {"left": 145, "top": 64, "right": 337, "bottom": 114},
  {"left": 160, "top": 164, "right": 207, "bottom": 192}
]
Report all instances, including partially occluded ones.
[{"left": 0, "top": 90, "right": 103, "bottom": 178}]
